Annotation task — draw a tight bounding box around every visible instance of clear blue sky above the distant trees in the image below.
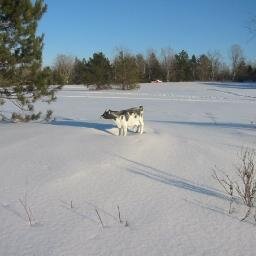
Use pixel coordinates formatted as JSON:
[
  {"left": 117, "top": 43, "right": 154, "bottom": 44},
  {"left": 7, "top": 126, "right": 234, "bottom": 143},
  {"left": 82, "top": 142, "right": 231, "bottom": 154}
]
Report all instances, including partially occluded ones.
[{"left": 38, "top": 0, "right": 256, "bottom": 65}]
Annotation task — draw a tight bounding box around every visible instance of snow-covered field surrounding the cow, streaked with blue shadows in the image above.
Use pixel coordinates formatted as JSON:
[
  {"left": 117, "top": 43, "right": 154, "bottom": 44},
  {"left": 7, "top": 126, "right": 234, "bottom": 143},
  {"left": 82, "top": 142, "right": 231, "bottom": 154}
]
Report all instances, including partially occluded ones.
[{"left": 0, "top": 83, "right": 256, "bottom": 256}]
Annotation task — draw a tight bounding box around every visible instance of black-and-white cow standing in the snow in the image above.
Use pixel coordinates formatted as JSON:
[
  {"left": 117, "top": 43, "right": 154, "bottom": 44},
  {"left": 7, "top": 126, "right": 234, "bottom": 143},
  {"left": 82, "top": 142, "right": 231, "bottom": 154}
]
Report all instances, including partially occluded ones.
[{"left": 101, "top": 106, "right": 144, "bottom": 136}]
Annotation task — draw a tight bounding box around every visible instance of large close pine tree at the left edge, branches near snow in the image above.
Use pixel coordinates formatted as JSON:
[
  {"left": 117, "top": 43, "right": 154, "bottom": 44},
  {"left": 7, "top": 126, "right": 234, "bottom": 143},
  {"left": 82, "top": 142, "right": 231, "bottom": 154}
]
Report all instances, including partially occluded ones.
[{"left": 0, "top": 0, "right": 55, "bottom": 121}]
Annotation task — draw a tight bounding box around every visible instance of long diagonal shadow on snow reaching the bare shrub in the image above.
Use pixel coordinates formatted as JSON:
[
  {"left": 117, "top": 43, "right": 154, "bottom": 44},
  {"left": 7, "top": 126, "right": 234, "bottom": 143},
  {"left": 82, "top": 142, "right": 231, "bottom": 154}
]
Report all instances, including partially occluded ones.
[{"left": 117, "top": 155, "right": 229, "bottom": 200}]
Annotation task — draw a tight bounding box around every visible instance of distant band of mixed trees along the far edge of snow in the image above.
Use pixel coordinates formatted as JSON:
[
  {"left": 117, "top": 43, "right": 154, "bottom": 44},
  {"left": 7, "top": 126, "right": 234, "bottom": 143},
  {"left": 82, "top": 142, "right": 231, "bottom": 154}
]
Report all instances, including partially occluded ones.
[{"left": 44, "top": 45, "right": 256, "bottom": 89}]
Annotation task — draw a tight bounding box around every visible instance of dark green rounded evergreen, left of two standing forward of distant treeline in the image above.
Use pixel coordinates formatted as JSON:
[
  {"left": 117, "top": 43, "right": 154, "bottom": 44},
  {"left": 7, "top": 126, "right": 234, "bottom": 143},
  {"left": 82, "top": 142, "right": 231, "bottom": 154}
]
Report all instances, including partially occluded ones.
[{"left": 87, "top": 52, "right": 111, "bottom": 89}]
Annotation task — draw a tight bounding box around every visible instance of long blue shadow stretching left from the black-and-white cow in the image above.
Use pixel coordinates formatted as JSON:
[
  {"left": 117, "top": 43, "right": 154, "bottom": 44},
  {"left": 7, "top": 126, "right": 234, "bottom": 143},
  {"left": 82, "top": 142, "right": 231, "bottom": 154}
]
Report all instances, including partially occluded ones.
[{"left": 50, "top": 118, "right": 115, "bottom": 135}]
